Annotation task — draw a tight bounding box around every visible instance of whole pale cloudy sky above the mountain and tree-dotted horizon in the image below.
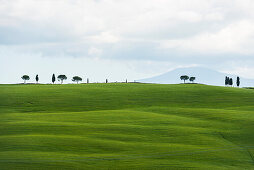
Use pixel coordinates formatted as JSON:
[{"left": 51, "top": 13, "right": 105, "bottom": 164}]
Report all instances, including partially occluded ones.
[{"left": 0, "top": 0, "right": 254, "bottom": 83}]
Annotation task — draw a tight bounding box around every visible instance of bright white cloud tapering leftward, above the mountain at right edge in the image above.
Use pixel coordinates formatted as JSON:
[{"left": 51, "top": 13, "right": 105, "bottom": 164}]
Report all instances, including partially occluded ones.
[{"left": 161, "top": 21, "right": 254, "bottom": 54}]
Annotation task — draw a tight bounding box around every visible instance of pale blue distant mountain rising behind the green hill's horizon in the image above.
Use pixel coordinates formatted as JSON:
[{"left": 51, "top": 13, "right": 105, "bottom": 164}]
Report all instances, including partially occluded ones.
[{"left": 137, "top": 67, "right": 254, "bottom": 87}]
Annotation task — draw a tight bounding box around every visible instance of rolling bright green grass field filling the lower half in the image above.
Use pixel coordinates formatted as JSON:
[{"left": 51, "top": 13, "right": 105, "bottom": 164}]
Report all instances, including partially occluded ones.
[{"left": 0, "top": 83, "right": 254, "bottom": 170}]
